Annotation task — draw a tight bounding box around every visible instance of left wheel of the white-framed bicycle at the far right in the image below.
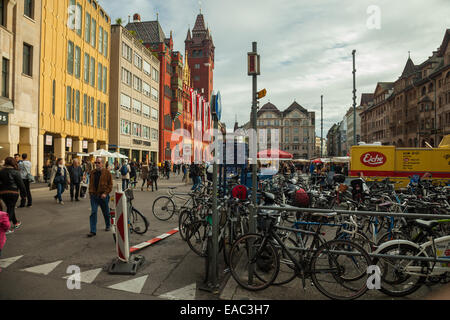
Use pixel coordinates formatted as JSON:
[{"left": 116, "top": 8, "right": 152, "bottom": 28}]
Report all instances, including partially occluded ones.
[{"left": 373, "top": 243, "right": 428, "bottom": 297}]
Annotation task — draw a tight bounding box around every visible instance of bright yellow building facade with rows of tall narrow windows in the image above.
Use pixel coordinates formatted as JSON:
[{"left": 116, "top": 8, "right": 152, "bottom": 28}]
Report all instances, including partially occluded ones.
[{"left": 38, "top": 0, "right": 111, "bottom": 168}]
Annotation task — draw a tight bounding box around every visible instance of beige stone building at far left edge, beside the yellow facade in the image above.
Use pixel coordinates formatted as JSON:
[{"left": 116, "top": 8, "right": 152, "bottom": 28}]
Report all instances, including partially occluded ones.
[{"left": 0, "top": 0, "right": 41, "bottom": 176}]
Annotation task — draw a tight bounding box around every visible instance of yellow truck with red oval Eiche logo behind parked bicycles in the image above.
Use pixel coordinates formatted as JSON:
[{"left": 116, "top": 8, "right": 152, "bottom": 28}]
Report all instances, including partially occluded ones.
[{"left": 350, "top": 139, "right": 450, "bottom": 188}]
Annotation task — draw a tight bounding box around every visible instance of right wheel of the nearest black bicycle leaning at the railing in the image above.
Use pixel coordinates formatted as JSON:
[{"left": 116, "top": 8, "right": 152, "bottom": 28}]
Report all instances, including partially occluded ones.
[{"left": 311, "top": 240, "right": 372, "bottom": 300}]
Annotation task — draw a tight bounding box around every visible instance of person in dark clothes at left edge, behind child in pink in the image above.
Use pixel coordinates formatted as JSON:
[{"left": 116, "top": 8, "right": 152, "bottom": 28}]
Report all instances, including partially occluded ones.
[{"left": 0, "top": 157, "right": 26, "bottom": 233}]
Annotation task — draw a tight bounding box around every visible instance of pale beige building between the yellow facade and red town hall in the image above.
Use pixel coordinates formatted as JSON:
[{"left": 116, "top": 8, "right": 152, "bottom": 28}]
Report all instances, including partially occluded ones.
[{"left": 109, "top": 25, "right": 160, "bottom": 163}]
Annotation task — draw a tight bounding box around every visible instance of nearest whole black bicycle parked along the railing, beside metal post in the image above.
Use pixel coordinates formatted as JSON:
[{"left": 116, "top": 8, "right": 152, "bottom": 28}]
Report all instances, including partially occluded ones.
[{"left": 229, "top": 212, "right": 371, "bottom": 300}]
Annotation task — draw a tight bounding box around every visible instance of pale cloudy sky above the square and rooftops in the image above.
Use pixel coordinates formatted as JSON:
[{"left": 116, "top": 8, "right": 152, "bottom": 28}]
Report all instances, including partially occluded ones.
[{"left": 99, "top": 0, "right": 450, "bottom": 137}]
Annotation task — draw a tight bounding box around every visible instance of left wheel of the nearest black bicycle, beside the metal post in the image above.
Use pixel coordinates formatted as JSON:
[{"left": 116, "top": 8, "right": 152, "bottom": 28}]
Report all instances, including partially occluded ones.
[{"left": 229, "top": 234, "right": 280, "bottom": 291}]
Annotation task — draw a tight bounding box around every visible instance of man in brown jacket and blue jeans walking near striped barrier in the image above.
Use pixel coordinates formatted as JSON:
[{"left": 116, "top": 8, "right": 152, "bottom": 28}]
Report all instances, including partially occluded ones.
[{"left": 87, "top": 158, "right": 112, "bottom": 238}]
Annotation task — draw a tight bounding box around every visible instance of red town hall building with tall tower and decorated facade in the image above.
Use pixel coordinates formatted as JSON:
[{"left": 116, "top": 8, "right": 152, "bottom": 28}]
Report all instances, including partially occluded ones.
[{"left": 125, "top": 14, "right": 214, "bottom": 162}]
